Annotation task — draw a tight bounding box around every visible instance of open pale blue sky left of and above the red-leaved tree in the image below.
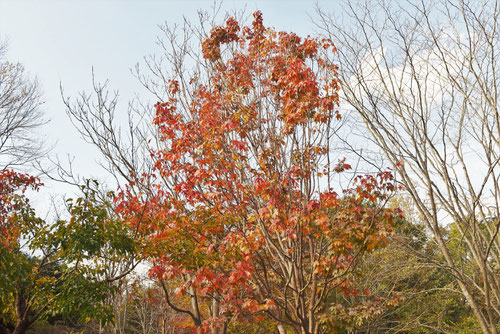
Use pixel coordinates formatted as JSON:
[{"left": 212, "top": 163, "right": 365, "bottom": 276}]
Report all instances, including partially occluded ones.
[{"left": 0, "top": 0, "right": 338, "bottom": 213}]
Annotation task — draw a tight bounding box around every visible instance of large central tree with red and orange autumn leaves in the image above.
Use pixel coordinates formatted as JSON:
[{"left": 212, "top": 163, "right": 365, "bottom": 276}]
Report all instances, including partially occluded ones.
[{"left": 115, "top": 12, "right": 399, "bottom": 334}]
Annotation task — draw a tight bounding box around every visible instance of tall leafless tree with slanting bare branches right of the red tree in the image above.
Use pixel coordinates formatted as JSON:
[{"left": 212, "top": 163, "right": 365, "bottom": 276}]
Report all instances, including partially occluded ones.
[{"left": 319, "top": 0, "right": 500, "bottom": 333}]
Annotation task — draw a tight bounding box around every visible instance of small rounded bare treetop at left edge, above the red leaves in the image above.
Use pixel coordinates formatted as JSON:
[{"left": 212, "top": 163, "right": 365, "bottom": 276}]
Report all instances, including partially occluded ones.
[{"left": 0, "top": 44, "right": 46, "bottom": 169}]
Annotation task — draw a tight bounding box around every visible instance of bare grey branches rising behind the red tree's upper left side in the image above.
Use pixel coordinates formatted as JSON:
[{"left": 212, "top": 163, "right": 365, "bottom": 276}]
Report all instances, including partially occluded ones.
[{"left": 60, "top": 5, "right": 230, "bottom": 193}]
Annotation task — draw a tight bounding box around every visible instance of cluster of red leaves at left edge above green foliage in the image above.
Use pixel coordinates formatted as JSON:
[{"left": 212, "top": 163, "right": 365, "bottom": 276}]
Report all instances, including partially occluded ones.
[{"left": 0, "top": 169, "right": 42, "bottom": 248}]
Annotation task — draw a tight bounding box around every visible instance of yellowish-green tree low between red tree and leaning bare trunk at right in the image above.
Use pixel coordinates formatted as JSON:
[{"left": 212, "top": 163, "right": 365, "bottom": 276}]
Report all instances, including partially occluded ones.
[{"left": 348, "top": 198, "right": 480, "bottom": 333}]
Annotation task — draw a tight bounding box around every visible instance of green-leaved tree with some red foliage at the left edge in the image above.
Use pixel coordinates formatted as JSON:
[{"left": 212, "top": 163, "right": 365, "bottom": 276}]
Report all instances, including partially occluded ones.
[{"left": 0, "top": 174, "right": 139, "bottom": 334}]
